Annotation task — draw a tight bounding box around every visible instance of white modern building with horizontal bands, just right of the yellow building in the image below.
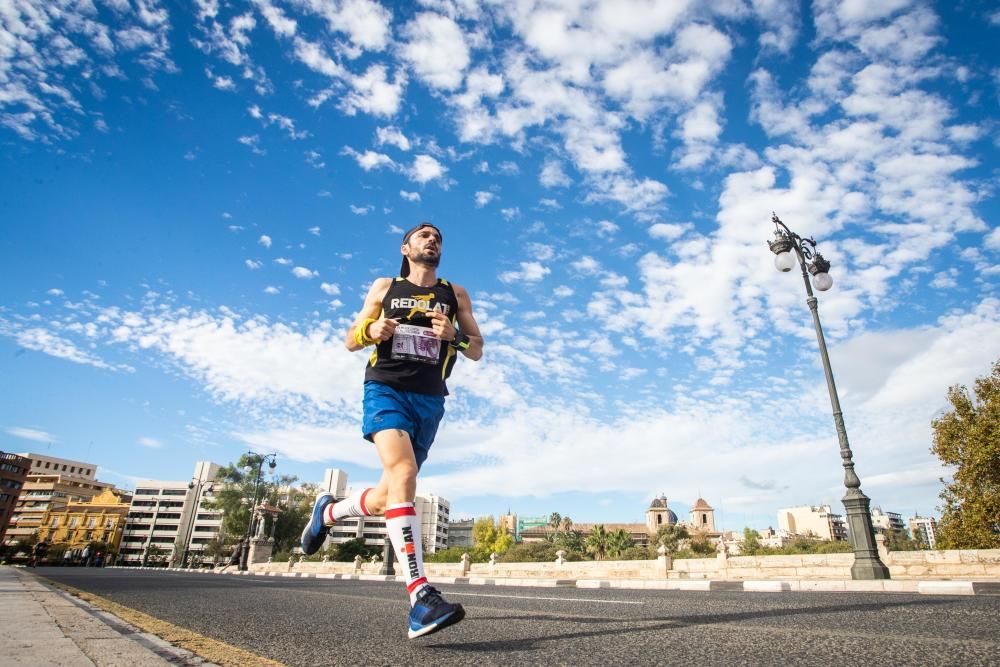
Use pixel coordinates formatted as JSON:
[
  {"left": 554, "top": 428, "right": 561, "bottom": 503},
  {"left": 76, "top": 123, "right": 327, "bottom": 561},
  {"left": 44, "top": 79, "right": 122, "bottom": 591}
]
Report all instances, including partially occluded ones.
[{"left": 119, "top": 461, "right": 222, "bottom": 565}]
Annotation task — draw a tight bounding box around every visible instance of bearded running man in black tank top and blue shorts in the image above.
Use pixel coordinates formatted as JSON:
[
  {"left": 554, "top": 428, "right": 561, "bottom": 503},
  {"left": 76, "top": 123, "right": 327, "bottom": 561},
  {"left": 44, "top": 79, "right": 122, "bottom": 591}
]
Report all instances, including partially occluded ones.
[{"left": 302, "top": 222, "right": 483, "bottom": 639}]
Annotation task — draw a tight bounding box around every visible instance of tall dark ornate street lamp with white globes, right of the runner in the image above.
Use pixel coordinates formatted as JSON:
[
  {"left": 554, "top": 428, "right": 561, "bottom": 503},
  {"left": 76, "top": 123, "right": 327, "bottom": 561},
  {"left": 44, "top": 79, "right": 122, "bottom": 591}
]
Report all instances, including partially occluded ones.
[{"left": 767, "top": 213, "right": 889, "bottom": 579}]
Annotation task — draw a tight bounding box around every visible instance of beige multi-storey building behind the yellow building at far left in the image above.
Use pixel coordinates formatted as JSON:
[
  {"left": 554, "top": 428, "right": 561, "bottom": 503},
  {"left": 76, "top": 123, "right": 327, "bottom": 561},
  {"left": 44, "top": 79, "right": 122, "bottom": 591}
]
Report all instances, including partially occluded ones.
[{"left": 4, "top": 453, "right": 114, "bottom": 544}]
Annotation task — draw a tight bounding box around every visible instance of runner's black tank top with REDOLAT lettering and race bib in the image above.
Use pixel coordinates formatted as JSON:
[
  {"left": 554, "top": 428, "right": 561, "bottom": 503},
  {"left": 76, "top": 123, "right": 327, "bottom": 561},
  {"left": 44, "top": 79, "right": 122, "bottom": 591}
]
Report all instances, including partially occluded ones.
[{"left": 365, "top": 278, "right": 458, "bottom": 396}]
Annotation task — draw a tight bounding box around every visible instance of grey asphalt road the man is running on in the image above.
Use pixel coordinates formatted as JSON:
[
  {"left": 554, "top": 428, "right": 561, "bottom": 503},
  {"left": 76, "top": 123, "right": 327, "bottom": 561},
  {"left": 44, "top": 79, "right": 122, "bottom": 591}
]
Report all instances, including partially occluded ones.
[{"left": 34, "top": 568, "right": 1000, "bottom": 667}]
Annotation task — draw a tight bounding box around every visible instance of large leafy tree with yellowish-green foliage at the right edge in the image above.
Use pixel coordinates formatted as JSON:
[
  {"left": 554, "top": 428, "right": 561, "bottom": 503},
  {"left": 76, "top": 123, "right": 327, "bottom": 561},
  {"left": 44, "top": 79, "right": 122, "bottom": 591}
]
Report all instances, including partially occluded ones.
[{"left": 931, "top": 361, "right": 1000, "bottom": 549}]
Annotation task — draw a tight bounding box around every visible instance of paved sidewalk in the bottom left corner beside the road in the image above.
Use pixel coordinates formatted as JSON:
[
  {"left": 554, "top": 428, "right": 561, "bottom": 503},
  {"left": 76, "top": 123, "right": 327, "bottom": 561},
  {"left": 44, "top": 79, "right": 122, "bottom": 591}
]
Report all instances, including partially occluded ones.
[{"left": 0, "top": 566, "right": 209, "bottom": 667}]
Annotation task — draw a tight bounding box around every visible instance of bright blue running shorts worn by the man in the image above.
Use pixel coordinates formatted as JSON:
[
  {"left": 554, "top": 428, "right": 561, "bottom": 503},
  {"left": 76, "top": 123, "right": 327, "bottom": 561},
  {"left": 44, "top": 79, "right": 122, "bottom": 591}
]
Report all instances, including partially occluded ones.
[{"left": 361, "top": 382, "right": 444, "bottom": 470}]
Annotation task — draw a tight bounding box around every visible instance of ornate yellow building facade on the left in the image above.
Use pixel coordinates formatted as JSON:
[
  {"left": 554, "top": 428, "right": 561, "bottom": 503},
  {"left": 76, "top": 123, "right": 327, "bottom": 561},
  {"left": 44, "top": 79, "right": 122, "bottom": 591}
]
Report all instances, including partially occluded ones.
[{"left": 38, "top": 489, "right": 131, "bottom": 553}]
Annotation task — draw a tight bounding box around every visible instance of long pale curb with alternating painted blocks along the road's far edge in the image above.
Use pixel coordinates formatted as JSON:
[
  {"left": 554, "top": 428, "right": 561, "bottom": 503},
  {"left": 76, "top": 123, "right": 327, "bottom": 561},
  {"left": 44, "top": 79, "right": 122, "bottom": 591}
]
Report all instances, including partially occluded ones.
[{"left": 105, "top": 566, "right": 1000, "bottom": 596}]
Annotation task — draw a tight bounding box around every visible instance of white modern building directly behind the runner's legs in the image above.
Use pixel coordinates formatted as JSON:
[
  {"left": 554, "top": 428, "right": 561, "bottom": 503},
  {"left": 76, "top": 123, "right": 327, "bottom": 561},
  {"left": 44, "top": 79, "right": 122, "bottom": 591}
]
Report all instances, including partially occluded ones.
[{"left": 321, "top": 468, "right": 451, "bottom": 553}]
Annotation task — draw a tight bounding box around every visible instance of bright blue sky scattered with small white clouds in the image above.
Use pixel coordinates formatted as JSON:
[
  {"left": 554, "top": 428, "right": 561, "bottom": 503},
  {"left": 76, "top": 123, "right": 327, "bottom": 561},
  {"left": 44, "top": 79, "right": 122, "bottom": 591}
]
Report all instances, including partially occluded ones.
[{"left": 0, "top": 0, "right": 1000, "bottom": 529}]
